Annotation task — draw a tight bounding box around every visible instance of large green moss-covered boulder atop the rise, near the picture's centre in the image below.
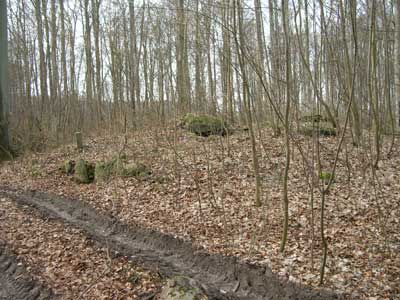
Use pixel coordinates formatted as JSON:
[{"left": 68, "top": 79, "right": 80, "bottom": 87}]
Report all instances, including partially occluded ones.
[{"left": 182, "top": 114, "right": 231, "bottom": 137}]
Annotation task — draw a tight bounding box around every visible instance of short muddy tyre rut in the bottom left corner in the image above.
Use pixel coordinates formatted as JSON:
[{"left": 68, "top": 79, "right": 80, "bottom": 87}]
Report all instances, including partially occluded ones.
[{"left": 0, "top": 242, "right": 55, "bottom": 300}]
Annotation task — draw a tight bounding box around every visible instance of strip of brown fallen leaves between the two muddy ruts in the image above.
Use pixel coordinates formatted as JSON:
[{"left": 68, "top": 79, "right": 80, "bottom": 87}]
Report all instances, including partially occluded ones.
[{"left": 0, "top": 197, "right": 162, "bottom": 300}]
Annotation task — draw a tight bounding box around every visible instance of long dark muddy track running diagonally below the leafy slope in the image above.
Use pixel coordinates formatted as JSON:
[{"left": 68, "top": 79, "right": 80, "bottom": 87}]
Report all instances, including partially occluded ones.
[{"left": 0, "top": 187, "right": 339, "bottom": 300}]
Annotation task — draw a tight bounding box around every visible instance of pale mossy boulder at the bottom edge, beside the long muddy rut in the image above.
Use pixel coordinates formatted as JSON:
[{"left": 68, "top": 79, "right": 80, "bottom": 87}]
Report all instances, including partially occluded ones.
[{"left": 159, "top": 276, "right": 208, "bottom": 300}]
